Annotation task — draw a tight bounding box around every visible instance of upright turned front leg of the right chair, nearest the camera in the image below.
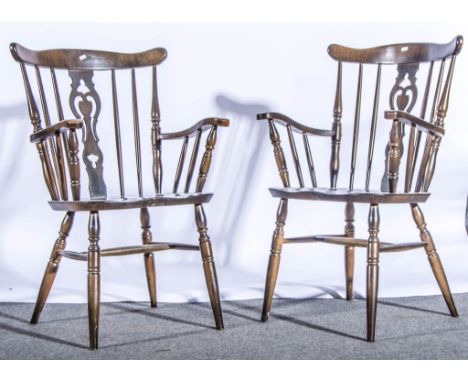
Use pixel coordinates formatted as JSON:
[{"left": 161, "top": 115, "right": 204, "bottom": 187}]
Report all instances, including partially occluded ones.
[{"left": 367, "top": 204, "right": 380, "bottom": 342}]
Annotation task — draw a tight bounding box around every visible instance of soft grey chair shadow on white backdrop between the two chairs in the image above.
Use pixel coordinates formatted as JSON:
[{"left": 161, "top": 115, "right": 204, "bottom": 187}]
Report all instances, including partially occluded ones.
[{"left": 210, "top": 94, "right": 270, "bottom": 265}]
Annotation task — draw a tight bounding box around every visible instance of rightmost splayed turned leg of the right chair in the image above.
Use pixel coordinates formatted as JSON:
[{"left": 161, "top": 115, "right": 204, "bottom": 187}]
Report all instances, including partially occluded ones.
[{"left": 411, "top": 204, "right": 458, "bottom": 317}]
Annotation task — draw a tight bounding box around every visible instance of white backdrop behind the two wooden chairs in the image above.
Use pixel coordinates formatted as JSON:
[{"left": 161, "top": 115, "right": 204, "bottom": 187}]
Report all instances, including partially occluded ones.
[{"left": 0, "top": 23, "right": 468, "bottom": 302}]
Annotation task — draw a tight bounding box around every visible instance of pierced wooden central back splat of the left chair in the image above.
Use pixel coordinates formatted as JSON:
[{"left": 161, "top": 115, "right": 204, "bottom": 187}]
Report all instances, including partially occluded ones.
[{"left": 68, "top": 70, "right": 107, "bottom": 199}]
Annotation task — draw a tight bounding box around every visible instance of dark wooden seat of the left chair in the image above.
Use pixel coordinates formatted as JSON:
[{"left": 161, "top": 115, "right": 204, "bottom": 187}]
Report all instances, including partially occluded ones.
[{"left": 49, "top": 192, "right": 213, "bottom": 211}]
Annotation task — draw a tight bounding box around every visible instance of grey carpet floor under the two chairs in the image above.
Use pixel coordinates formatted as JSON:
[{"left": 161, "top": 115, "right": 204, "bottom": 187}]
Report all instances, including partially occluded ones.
[{"left": 0, "top": 294, "right": 468, "bottom": 359}]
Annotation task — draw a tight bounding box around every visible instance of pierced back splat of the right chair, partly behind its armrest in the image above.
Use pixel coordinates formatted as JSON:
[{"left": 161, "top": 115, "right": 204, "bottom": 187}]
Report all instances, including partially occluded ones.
[{"left": 380, "top": 63, "right": 419, "bottom": 192}]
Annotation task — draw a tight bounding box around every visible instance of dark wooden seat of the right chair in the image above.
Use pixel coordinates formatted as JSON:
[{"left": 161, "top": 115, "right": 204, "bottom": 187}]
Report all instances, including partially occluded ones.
[{"left": 270, "top": 187, "right": 431, "bottom": 204}]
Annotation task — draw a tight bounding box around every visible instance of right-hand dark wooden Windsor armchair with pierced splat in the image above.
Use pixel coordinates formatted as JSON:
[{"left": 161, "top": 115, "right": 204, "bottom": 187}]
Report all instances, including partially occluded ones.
[{"left": 257, "top": 36, "right": 463, "bottom": 342}]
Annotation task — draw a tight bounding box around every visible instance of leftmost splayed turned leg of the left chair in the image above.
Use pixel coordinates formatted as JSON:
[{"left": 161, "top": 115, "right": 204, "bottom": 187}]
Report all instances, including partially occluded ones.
[{"left": 31, "top": 212, "right": 75, "bottom": 324}]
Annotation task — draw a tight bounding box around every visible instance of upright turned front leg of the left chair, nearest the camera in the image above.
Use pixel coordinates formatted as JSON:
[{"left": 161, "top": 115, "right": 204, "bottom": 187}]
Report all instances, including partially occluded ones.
[{"left": 88, "top": 211, "right": 101, "bottom": 350}]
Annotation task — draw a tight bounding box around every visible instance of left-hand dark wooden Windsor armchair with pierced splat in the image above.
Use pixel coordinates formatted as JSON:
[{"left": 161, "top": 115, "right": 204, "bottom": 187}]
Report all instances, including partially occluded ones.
[{"left": 10, "top": 43, "right": 229, "bottom": 349}]
